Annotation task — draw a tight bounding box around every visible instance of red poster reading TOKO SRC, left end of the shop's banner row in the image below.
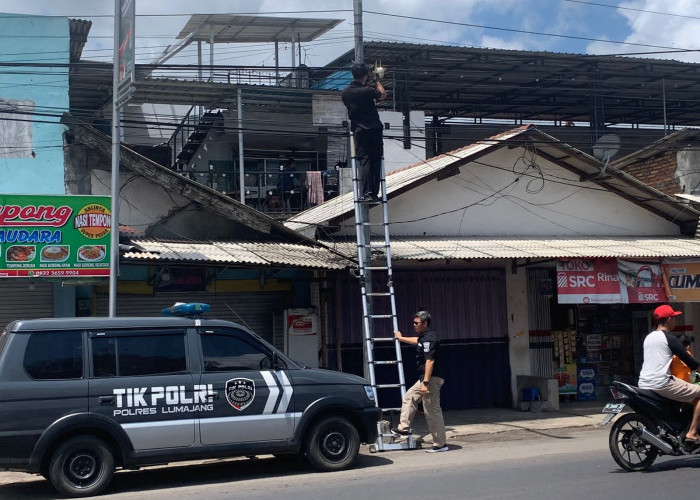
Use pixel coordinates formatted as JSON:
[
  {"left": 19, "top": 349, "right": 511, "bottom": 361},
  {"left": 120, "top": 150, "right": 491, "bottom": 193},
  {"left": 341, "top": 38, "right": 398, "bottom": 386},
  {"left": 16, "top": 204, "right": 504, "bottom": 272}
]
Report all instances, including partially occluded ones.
[{"left": 557, "top": 259, "right": 624, "bottom": 304}]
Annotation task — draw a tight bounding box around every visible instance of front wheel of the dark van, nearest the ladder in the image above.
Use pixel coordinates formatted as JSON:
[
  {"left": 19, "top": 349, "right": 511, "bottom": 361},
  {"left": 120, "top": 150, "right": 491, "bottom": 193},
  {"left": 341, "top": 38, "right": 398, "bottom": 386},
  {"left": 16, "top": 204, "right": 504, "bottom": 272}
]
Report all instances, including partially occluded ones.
[{"left": 306, "top": 417, "right": 360, "bottom": 471}]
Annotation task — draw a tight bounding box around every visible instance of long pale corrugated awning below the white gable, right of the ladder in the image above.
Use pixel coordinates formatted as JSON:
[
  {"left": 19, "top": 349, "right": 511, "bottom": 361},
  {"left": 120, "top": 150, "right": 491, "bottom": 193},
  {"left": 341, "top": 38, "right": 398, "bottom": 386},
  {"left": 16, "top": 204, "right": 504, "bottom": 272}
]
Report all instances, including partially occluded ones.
[{"left": 324, "top": 236, "right": 700, "bottom": 261}]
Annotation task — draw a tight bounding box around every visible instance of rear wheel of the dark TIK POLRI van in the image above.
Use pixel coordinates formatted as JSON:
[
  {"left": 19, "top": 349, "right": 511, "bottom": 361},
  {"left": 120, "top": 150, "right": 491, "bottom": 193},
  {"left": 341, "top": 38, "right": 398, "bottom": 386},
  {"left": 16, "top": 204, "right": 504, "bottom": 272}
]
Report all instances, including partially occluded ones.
[{"left": 49, "top": 436, "right": 114, "bottom": 497}]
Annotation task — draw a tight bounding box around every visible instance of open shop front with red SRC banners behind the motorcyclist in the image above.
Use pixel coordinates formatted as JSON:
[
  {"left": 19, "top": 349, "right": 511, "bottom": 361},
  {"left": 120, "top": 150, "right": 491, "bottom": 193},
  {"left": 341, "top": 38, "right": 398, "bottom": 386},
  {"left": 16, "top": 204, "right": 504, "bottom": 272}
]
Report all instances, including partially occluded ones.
[{"left": 528, "top": 258, "right": 700, "bottom": 400}]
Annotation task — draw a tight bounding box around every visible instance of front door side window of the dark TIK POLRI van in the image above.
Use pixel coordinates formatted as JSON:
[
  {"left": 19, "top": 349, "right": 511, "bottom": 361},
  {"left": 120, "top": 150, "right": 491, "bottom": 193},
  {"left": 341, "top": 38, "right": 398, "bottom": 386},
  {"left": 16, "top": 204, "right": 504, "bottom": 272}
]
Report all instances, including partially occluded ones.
[{"left": 199, "top": 332, "right": 271, "bottom": 372}]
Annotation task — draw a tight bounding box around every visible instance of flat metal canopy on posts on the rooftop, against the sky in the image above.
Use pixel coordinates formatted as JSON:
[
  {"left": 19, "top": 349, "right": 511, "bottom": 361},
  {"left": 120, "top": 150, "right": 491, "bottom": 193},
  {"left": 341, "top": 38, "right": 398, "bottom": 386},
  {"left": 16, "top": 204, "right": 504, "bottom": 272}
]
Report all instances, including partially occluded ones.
[{"left": 176, "top": 14, "right": 343, "bottom": 43}]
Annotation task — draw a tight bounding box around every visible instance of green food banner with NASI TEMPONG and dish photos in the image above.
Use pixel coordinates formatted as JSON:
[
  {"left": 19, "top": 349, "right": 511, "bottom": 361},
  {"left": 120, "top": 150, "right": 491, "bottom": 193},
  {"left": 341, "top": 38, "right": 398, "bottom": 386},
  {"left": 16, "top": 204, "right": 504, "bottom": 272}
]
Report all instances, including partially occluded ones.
[{"left": 0, "top": 195, "right": 112, "bottom": 278}]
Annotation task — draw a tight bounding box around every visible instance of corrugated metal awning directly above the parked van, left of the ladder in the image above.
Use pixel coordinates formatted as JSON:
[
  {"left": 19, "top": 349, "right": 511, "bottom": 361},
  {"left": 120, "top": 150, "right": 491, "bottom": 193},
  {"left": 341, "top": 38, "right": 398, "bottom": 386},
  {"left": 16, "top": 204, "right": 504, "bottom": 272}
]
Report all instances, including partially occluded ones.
[{"left": 122, "top": 239, "right": 352, "bottom": 269}]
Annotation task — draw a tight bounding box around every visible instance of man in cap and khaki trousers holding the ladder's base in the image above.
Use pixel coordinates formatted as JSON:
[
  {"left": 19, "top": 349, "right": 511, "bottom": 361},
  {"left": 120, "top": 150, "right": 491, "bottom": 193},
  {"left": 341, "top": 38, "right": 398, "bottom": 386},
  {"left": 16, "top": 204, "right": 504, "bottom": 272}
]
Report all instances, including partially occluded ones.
[{"left": 392, "top": 311, "right": 449, "bottom": 453}]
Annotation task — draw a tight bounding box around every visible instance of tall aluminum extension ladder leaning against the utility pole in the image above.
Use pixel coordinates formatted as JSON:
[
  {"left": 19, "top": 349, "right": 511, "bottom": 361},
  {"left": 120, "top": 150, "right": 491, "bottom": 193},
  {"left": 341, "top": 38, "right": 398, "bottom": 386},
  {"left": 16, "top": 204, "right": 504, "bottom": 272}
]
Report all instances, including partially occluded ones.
[{"left": 348, "top": 126, "right": 419, "bottom": 452}]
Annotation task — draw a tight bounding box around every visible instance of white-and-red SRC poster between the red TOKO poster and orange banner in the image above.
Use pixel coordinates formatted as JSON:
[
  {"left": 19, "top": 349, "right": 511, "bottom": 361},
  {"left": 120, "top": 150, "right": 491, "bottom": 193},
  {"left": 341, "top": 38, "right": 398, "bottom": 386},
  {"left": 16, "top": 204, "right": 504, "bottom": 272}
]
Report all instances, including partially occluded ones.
[{"left": 617, "top": 259, "right": 667, "bottom": 304}]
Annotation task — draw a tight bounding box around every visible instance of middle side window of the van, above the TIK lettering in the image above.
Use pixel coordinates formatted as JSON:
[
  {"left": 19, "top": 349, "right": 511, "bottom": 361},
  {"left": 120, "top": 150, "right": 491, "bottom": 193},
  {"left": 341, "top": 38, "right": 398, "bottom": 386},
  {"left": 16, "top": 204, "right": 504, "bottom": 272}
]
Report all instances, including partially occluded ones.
[{"left": 91, "top": 332, "right": 187, "bottom": 377}]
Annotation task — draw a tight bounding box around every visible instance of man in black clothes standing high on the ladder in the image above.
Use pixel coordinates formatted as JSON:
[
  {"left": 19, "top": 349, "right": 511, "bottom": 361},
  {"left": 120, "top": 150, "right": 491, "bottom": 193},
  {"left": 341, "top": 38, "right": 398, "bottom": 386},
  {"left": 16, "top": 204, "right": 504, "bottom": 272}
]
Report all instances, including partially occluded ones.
[{"left": 343, "top": 64, "right": 386, "bottom": 202}]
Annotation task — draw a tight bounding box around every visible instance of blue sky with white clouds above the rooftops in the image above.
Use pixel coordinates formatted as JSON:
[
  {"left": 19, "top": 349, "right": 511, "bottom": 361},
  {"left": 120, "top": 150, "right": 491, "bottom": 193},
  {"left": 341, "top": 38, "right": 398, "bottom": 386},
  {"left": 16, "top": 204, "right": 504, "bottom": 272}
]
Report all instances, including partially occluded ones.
[{"left": 0, "top": 0, "right": 700, "bottom": 67}]
